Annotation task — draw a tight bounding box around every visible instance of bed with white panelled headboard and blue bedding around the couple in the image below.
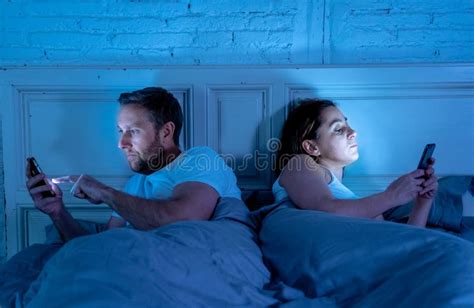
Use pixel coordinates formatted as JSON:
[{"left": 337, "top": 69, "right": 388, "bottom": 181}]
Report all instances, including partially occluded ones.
[{"left": 0, "top": 64, "right": 474, "bottom": 307}]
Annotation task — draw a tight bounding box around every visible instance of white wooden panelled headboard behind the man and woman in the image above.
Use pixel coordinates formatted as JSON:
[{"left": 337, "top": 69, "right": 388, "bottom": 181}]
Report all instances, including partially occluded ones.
[{"left": 0, "top": 64, "right": 474, "bottom": 257}]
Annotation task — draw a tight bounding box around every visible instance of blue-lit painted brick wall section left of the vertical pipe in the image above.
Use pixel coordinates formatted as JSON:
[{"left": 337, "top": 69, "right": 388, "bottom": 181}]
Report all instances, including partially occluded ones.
[{"left": 0, "top": 0, "right": 324, "bottom": 65}]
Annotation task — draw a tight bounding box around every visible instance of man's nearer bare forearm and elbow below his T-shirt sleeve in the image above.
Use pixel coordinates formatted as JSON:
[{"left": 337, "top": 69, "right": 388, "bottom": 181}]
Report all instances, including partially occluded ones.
[{"left": 101, "top": 182, "right": 219, "bottom": 230}]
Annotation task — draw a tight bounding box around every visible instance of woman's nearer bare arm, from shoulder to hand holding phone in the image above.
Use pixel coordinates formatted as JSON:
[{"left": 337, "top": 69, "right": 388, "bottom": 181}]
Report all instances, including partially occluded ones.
[{"left": 280, "top": 154, "right": 423, "bottom": 218}]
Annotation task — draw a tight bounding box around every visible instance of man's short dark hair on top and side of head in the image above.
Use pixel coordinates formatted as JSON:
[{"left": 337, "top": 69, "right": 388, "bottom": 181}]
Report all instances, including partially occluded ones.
[{"left": 118, "top": 87, "right": 183, "bottom": 145}]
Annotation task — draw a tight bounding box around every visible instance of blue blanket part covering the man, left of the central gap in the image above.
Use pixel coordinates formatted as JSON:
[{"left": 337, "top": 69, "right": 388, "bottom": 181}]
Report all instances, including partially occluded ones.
[{"left": 0, "top": 199, "right": 278, "bottom": 307}]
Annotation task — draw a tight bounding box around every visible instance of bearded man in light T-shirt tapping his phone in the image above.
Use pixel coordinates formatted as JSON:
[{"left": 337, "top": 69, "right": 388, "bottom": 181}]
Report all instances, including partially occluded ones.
[{"left": 26, "top": 87, "right": 240, "bottom": 240}]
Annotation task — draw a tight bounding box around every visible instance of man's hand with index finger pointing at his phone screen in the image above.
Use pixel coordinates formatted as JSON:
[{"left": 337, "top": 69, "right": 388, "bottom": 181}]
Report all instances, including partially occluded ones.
[{"left": 53, "top": 174, "right": 110, "bottom": 204}]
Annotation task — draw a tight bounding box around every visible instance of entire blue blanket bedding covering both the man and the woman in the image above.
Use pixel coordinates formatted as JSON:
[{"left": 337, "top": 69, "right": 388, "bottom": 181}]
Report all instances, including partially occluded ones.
[{"left": 0, "top": 196, "right": 474, "bottom": 307}]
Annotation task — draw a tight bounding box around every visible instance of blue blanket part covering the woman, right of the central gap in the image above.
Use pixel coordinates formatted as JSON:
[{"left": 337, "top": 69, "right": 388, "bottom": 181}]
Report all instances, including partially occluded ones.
[{"left": 260, "top": 201, "right": 474, "bottom": 307}]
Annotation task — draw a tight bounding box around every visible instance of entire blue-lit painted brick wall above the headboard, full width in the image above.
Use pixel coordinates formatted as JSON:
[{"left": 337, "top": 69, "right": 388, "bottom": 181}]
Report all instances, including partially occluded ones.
[{"left": 0, "top": 0, "right": 474, "bottom": 65}]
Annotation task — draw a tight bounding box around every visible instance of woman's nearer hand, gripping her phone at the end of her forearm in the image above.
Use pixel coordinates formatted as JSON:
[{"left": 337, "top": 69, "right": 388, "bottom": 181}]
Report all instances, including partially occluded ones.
[{"left": 384, "top": 169, "right": 425, "bottom": 205}]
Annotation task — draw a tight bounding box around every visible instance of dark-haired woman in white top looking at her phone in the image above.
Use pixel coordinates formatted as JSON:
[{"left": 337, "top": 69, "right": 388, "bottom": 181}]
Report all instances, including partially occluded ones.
[{"left": 272, "top": 99, "right": 438, "bottom": 227}]
